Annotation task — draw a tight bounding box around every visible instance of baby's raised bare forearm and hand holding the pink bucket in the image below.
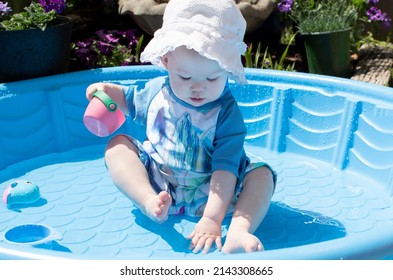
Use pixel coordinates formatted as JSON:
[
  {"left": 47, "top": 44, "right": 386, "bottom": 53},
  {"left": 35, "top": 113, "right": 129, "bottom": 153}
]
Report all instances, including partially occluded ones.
[{"left": 86, "top": 83, "right": 129, "bottom": 115}]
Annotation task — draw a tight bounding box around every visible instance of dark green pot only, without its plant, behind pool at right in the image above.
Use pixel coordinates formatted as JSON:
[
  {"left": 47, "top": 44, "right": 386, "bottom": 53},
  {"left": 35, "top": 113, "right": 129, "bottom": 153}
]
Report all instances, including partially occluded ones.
[{"left": 302, "top": 29, "right": 351, "bottom": 78}]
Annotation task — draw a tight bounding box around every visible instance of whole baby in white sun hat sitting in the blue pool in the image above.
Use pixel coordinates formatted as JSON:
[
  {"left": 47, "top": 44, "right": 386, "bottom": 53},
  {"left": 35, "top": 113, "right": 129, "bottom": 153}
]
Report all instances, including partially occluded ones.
[{"left": 86, "top": 0, "right": 276, "bottom": 253}]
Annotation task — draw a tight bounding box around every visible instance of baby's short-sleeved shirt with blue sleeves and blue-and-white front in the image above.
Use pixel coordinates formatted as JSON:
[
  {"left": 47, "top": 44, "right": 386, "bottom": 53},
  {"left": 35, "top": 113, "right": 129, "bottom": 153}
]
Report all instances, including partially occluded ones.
[{"left": 124, "top": 77, "right": 249, "bottom": 178}]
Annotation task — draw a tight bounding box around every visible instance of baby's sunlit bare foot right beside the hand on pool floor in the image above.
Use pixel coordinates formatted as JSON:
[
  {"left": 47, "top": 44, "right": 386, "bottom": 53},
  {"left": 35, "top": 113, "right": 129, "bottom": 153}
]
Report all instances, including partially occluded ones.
[{"left": 222, "top": 229, "right": 264, "bottom": 254}]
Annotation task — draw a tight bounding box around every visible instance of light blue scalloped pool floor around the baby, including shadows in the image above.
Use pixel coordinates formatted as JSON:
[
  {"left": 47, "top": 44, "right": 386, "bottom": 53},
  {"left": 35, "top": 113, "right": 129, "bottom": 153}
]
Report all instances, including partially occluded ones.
[{"left": 0, "top": 146, "right": 393, "bottom": 259}]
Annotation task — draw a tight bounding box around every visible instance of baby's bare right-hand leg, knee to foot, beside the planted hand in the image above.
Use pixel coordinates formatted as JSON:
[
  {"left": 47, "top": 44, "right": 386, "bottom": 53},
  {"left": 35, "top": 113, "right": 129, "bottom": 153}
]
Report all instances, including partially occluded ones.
[{"left": 222, "top": 167, "right": 274, "bottom": 254}]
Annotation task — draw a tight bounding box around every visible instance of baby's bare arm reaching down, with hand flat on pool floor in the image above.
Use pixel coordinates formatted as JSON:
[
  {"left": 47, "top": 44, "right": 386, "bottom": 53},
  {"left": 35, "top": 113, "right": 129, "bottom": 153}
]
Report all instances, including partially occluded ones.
[{"left": 189, "top": 170, "right": 236, "bottom": 253}]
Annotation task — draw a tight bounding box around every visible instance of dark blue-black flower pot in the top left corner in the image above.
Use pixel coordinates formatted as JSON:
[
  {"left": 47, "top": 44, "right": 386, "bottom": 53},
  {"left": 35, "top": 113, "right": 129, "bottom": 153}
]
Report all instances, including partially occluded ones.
[{"left": 0, "top": 16, "right": 72, "bottom": 83}]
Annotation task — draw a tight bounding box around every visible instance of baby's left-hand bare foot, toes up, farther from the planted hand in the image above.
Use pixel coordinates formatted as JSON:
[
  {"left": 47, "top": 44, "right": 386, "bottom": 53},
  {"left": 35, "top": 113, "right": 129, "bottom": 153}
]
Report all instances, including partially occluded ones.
[{"left": 141, "top": 191, "right": 172, "bottom": 223}]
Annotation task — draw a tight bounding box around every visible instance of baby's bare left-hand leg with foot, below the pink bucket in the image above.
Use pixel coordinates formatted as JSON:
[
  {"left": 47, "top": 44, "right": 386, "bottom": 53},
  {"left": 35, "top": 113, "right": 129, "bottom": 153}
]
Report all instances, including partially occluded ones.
[{"left": 105, "top": 135, "right": 172, "bottom": 223}]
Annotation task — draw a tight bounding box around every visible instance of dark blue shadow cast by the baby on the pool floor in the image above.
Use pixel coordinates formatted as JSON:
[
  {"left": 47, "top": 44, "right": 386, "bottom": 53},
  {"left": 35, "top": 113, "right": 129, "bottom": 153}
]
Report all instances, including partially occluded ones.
[{"left": 132, "top": 202, "right": 346, "bottom": 254}]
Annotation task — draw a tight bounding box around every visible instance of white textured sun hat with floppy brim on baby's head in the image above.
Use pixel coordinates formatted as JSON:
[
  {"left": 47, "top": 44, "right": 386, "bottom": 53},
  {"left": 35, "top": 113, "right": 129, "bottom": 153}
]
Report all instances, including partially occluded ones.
[{"left": 141, "top": 0, "right": 247, "bottom": 83}]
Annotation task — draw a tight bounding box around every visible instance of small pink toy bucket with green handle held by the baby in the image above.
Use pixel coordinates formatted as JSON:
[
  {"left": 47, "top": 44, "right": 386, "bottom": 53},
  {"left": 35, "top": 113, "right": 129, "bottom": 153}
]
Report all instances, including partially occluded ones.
[{"left": 83, "top": 90, "right": 126, "bottom": 137}]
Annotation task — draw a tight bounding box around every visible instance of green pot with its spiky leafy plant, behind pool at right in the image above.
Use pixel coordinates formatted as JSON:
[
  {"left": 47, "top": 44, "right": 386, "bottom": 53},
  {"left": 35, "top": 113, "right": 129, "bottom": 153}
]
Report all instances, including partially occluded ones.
[{"left": 277, "top": 0, "right": 357, "bottom": 77}]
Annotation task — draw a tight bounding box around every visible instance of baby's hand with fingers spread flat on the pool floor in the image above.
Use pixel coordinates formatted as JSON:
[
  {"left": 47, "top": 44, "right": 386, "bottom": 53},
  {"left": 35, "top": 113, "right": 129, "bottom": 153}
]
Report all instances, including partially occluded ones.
[{"left": 188, "top": 217, "right": 222, "bottom": 254}]
